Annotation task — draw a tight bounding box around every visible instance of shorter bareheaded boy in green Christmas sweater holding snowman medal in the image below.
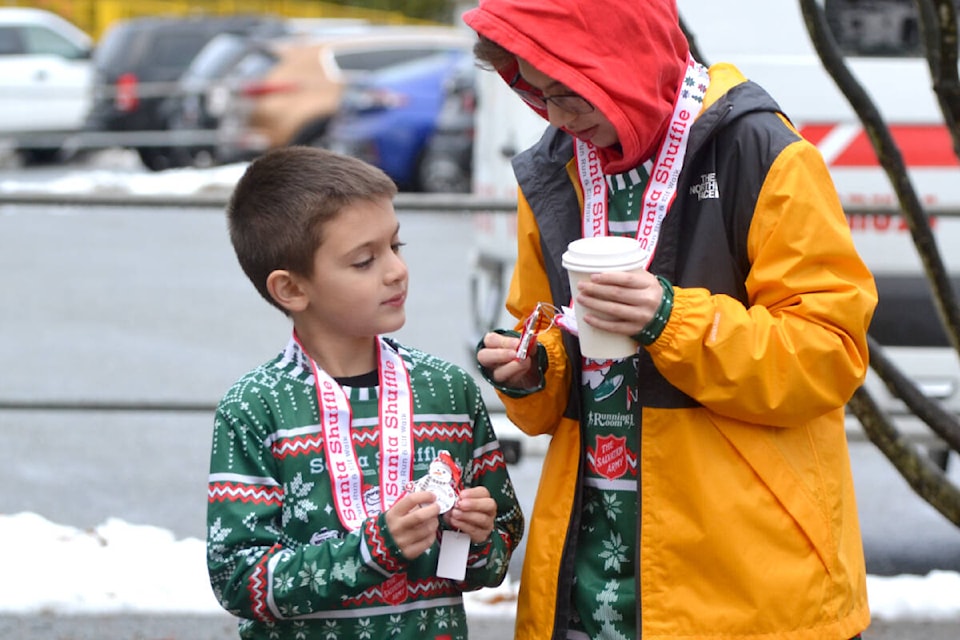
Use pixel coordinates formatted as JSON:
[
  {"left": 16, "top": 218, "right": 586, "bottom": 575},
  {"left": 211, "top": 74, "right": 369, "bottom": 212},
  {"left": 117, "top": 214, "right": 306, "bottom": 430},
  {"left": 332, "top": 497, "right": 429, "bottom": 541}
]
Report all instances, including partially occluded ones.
[{"left": 207, "top": 147, "right": 523, "bottom": 640}]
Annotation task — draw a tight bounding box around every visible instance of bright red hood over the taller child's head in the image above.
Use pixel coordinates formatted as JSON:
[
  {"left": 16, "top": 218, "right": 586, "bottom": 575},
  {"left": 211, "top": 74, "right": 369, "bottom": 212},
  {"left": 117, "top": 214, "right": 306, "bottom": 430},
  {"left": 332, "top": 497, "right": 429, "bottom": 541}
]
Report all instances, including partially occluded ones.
[{"left": 463, "top": 0, "right": 689, "bottom": 174}]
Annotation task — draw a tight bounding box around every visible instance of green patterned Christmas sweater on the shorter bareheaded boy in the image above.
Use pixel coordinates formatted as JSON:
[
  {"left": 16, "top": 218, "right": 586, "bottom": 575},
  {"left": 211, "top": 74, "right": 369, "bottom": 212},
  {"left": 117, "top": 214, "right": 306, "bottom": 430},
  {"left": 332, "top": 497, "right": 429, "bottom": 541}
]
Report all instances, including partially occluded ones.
[{"left": 207, "top": 339, "right": 524, "bottom": 640}]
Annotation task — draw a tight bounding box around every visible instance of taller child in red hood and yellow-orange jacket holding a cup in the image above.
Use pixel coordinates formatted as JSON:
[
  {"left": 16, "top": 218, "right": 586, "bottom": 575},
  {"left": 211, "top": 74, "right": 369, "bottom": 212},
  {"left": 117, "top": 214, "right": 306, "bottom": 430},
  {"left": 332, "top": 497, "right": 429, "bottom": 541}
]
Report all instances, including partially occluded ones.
[{"left": 464, "top": 0, "right": 877, "bottom": 640}]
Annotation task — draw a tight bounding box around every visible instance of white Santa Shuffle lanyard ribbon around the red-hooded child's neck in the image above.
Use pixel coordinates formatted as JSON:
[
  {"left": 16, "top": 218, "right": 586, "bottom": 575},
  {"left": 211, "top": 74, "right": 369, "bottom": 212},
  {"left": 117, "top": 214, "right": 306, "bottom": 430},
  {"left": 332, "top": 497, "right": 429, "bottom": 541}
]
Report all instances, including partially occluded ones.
[{"left": 576, "top": 56, "right": 710, "bottom": 268}]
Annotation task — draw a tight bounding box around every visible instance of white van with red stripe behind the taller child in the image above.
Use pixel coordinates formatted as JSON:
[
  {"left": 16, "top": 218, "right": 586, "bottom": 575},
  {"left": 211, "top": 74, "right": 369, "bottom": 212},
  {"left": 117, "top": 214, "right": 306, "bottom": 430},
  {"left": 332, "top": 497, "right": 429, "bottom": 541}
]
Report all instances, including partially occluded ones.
[{"left": 469, "top": 0, "right": 960, "bottom": 448}]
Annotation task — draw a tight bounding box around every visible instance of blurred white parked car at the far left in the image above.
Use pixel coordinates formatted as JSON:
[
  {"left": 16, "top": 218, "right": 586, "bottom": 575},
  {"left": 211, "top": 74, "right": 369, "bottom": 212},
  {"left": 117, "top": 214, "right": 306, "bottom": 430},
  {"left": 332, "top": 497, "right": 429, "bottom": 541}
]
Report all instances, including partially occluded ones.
[{"left": 0, "top": 7, "right": 93, "bottom": 162}]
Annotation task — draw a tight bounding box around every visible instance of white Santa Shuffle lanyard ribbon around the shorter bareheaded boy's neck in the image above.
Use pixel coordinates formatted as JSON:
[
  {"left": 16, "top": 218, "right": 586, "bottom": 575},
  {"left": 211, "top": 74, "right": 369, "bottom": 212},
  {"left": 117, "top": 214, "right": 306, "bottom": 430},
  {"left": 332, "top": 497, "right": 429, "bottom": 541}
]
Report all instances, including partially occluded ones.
[{"left": 294, "top": 334, "right": 413, "bottom": 531}]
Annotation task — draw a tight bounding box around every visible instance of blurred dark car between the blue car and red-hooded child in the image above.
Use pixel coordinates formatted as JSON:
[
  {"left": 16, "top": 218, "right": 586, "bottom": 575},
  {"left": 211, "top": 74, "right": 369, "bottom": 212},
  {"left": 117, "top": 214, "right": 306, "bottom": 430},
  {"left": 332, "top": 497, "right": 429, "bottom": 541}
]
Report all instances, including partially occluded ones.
[{"left": 420, "top": 57, "right": 477, "bottom": 193}]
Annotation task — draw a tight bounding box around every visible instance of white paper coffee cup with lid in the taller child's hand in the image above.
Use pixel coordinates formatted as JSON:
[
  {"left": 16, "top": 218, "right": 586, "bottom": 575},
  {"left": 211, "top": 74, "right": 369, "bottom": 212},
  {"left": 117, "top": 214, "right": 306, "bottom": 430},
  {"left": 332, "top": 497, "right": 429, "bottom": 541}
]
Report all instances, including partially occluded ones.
[{"left": 563, "top": 236, "right": 644, "bottom": 360}]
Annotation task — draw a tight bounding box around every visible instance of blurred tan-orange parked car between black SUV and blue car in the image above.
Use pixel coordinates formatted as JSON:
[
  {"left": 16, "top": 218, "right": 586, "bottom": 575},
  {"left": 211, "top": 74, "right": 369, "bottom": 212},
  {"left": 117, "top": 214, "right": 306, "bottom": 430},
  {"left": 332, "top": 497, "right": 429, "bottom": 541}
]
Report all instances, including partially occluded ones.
[{"left": 217, "top": 27, "right": 472, "bottom": 162}]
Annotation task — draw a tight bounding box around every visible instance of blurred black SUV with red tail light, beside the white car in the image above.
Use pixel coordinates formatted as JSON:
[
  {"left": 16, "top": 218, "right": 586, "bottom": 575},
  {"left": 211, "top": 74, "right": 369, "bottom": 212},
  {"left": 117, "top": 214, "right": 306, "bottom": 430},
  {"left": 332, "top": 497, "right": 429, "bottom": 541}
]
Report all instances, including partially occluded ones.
[{"left": 86, "top": 15, "right": 287, "bottom": 170}]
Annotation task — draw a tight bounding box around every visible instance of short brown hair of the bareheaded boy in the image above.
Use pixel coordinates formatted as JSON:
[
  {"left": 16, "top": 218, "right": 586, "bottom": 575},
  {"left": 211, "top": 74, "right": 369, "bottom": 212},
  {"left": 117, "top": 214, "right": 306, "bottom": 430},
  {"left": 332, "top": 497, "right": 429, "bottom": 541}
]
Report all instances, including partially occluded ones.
[{"left": 227, "top": 146, "right": 397, "bottom": 313}]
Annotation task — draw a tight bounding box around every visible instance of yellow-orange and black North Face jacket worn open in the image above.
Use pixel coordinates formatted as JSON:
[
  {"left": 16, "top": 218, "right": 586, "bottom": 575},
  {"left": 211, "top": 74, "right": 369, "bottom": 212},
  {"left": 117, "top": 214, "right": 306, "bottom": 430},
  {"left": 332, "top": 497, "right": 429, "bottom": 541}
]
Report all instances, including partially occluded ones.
[{"left": 468, "top": 22, "right": 876, "bottom": 640}]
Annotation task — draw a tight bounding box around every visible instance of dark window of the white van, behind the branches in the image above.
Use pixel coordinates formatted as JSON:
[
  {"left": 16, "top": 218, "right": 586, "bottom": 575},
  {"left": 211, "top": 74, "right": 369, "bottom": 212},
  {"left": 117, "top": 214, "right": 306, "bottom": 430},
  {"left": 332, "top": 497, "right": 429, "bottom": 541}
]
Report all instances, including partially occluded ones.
[{"left": 824, "top": 0, "right": 960, "bottom": 58}]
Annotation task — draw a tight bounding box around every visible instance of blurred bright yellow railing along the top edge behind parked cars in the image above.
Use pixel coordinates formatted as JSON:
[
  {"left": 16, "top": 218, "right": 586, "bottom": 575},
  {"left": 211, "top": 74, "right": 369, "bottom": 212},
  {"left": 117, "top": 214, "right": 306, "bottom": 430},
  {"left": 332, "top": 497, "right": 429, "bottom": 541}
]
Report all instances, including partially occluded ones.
[{"left": 0, "top": 0, "right": 427, "bottom": 39}]
